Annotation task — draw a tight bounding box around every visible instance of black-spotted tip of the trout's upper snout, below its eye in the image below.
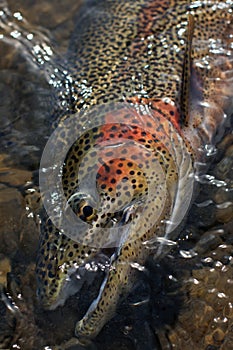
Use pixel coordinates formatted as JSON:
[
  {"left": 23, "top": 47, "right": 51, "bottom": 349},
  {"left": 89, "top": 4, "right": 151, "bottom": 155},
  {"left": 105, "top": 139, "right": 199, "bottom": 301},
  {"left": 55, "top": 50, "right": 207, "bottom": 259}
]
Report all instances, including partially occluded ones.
[{"left": 36, "top": 218, "right": 99, "bottom": 310}]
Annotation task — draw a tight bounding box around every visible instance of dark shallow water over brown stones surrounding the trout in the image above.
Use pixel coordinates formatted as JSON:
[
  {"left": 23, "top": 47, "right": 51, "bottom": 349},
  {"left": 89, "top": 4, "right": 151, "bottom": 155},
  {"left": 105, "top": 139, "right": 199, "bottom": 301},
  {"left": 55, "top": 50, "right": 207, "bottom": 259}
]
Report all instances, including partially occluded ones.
[{"left": 0, "top": 0, "right": 233, "bottom": 350}]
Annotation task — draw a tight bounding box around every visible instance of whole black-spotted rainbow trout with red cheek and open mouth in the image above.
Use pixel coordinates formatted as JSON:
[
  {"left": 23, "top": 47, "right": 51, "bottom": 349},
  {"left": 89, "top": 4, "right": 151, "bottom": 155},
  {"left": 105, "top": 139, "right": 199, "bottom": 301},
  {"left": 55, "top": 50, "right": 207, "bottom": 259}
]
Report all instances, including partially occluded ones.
[{"left": 37, "top": 0, "right": 233, "bottom": 339}]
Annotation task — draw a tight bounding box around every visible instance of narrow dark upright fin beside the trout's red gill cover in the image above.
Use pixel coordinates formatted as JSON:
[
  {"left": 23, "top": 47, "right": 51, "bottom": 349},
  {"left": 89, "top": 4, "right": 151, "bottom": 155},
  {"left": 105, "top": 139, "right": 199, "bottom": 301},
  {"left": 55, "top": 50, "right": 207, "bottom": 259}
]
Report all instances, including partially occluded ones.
[{"left": 180, "top": 14, "right": 194, "bottom": 126}]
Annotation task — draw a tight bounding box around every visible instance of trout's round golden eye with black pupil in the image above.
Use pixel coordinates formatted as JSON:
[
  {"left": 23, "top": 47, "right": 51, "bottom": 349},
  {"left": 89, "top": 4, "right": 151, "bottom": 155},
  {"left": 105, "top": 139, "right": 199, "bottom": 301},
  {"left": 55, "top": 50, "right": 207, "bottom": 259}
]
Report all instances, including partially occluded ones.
[{"left": 67, "top": 192, "right": 97, "bottom": 222}]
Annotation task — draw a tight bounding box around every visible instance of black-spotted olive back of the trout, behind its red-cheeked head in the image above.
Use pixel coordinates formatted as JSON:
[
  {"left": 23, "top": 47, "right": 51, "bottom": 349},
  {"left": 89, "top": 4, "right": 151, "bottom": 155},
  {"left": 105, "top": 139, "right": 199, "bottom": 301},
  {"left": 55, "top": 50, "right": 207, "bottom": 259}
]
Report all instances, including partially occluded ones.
[{"left": 68, "top": 0, "right": 232, "bottom": 123}]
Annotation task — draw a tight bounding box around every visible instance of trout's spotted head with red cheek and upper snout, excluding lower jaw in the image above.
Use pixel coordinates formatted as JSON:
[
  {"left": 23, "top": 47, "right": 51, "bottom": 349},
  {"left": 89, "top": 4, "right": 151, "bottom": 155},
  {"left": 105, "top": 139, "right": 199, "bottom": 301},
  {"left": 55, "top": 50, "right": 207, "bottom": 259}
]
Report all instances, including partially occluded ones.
[{"left": 37, "top": 105, "right": 192, "bottom": 308}]
